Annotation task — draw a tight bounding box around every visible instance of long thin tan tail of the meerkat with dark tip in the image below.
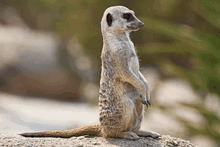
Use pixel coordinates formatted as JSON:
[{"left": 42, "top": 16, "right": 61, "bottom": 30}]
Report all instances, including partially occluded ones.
[{"left": 19, "top": 125, "right": 101, "bottom": 138}]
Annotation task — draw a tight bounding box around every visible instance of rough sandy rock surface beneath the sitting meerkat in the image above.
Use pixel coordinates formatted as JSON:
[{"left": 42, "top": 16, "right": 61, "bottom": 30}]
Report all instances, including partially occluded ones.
[{"left": 0, "top": 133, "right": 194, "bottom": 147}]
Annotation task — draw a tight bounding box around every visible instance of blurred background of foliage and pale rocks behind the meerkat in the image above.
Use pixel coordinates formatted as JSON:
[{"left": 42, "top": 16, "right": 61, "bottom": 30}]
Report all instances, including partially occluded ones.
[{"left": 0, "top": 0, "right": 220, "bottom": 147}]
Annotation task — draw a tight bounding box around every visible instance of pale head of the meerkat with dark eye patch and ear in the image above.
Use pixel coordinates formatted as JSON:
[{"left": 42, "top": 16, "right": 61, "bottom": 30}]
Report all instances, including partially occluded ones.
[{"left": 101, "top": 6, "right": 144, "bottom": 33}]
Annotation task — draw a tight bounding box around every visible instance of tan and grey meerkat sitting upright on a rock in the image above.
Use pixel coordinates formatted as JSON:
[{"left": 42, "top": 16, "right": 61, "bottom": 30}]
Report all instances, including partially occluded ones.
[{"left": 20, "top": 6, "right": 160, "bottom": 140}]
